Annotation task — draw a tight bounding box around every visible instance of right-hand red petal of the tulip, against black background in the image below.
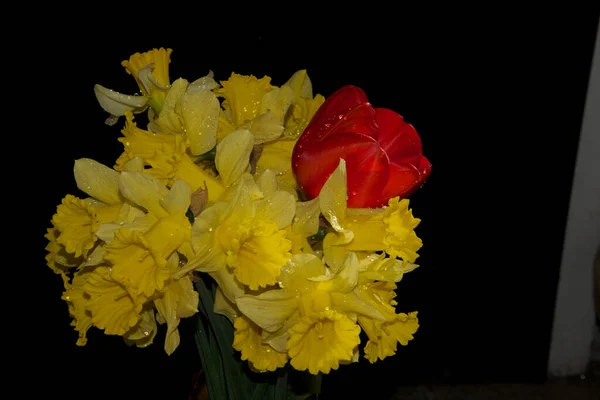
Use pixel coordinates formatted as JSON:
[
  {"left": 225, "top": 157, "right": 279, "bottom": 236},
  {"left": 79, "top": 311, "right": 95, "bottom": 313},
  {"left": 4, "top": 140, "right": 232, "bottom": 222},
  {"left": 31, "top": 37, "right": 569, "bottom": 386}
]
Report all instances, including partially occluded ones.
[{"left": 375, "top": 108, "right": 423, "bottom": 166}]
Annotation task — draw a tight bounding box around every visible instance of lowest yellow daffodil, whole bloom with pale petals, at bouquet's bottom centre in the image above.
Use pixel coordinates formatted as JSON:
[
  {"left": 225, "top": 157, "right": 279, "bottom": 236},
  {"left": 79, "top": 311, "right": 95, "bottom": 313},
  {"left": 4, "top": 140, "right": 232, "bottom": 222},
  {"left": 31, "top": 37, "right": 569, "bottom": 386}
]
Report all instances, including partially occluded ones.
[{"left": 236, "top": 253, "right": 384, "bottom": 374}]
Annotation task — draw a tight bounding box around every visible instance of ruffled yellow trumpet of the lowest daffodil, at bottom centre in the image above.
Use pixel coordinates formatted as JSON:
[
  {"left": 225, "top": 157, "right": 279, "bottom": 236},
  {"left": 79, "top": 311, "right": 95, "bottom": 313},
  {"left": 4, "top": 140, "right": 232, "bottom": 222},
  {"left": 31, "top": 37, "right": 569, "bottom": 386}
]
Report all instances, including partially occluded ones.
[{"left": 287, "top": 310, "right": 360, "bottom": 375}]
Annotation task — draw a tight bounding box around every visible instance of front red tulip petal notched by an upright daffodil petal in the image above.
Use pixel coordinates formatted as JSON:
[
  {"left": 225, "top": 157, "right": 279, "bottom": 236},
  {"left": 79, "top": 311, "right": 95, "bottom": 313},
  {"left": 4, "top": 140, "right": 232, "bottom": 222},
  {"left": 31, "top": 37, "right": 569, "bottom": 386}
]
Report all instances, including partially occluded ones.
[{"left": 296, "top": 133, "right": 389, "bottom": 208}]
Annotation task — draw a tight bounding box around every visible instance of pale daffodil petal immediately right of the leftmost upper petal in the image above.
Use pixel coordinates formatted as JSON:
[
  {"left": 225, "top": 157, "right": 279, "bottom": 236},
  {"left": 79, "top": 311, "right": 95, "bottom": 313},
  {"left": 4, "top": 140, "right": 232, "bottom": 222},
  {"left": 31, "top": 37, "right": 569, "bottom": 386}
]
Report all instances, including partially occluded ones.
[{"left": 119, "top": 172, "right": 169, "bottom": 217}]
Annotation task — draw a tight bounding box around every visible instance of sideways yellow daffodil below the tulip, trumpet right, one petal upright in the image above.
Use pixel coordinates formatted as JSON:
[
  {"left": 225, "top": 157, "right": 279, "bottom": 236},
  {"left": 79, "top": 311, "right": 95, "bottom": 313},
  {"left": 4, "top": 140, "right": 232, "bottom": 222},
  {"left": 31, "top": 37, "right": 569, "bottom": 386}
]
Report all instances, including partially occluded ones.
[{"left": 319, "top": 159, "right": 423, "bottom": 268}]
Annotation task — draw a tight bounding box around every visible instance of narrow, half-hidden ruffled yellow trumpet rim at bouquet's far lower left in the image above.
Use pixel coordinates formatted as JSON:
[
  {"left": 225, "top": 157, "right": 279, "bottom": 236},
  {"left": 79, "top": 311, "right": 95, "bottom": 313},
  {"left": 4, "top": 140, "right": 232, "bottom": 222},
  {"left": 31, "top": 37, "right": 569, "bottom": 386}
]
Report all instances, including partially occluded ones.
[{"left": 61, "top": 270, "right": 92, "bottom": 346}]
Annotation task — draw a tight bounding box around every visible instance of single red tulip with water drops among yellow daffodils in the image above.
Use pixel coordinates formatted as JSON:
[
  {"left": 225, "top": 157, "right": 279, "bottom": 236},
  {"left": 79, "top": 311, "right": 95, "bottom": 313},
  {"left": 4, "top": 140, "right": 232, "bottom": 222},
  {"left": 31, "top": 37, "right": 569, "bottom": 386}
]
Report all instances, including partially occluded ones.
[{"left": 292, "top": 86, "right": 431, "bottom": 208}]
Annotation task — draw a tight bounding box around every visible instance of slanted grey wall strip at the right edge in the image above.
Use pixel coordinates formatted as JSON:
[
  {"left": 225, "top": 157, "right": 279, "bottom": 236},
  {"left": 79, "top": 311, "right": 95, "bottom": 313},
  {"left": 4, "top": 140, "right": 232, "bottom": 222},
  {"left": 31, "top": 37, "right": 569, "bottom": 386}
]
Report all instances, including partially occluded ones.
[{"left": 548, "top": 21, "right": 600, "bottom": 376}]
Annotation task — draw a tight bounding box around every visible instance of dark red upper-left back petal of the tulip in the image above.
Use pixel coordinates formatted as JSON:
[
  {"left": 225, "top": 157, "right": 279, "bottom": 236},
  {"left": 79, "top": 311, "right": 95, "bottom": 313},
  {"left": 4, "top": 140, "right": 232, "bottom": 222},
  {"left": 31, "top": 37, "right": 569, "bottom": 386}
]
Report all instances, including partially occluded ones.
[{"left": 292, "top": 85, "right": 377, "bottom": 172}]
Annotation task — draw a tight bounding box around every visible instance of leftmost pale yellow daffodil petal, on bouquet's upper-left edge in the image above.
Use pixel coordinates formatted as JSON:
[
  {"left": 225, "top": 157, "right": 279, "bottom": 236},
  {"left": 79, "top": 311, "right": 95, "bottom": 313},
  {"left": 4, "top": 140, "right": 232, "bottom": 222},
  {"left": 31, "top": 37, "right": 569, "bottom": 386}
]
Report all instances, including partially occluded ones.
[{"left": 73, "top": 158, "right": 122, "bottom": 204}]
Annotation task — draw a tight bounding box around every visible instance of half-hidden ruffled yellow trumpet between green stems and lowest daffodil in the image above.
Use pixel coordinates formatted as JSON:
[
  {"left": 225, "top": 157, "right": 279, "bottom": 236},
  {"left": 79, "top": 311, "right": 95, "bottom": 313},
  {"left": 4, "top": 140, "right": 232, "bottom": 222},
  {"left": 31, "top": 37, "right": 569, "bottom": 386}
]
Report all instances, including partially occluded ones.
[{"left": 233, "top": 317, "right": 288, "bottom": 372}]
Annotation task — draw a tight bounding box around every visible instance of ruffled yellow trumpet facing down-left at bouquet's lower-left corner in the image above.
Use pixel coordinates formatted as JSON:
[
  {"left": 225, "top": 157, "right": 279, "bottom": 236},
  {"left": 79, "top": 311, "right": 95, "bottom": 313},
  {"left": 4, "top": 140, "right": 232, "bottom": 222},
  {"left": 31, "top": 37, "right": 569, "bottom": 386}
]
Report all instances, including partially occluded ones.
[{"left": 84, "top": 267, "right": 145, "bottom": 336}]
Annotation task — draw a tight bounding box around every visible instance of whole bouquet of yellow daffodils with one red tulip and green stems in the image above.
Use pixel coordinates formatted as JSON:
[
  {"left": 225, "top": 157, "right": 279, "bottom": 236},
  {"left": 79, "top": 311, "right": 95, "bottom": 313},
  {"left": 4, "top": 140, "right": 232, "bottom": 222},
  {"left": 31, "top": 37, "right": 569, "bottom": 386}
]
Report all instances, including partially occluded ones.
[{"left": 46, "top": 48, "right": 431, "bottom": 399}]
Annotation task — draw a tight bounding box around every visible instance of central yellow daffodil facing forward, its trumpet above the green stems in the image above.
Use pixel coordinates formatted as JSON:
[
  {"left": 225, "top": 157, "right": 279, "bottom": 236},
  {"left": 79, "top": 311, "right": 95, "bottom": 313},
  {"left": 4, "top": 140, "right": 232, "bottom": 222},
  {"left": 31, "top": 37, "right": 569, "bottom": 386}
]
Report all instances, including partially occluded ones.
[{"left": 188, "top": 168, "right": 295, "bottom": 290}]
